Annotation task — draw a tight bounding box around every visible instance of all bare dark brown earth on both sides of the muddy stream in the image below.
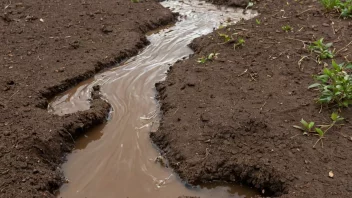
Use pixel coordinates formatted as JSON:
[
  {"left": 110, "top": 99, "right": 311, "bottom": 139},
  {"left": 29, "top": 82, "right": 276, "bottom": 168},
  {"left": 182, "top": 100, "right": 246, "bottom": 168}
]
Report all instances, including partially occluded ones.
[{"left": 0, "top": 0, "right": 352, "bottom": 198}]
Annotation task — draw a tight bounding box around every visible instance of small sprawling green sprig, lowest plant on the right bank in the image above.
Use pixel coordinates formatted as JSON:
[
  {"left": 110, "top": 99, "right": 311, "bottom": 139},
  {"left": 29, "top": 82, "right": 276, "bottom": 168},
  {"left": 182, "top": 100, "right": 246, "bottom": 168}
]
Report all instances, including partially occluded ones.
[{"left": 293, "top": 112, "right": 344, "bottom": 148}]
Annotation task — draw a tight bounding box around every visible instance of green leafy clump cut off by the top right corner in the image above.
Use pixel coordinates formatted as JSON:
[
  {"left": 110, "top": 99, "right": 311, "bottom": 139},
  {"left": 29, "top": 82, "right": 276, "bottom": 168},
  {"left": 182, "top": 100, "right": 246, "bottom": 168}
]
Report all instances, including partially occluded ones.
[{"left": 320, "top": 0, "right": 352, "bottom": 18}]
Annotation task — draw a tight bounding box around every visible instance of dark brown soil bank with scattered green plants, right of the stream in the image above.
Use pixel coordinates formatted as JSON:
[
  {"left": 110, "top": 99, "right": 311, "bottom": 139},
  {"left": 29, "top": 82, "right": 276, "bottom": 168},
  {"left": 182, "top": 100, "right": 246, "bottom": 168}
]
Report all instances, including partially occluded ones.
[{"left": 151, "top": 0, "right": 352, "bottom": 198}]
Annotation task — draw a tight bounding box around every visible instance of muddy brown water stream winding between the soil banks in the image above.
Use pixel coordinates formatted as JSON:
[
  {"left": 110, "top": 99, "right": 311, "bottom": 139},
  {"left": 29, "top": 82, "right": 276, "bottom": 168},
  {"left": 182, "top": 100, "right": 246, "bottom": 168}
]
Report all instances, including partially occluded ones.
[{"left": 48, "top": 0, "right": 257, "bottom": 198}]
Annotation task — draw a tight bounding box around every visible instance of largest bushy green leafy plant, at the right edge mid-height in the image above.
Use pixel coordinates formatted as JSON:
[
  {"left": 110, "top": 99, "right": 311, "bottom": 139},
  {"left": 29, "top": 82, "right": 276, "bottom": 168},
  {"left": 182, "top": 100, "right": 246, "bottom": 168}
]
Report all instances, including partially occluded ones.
[{"left": 308, "top": 60, "right": 352, "bottom": 107}]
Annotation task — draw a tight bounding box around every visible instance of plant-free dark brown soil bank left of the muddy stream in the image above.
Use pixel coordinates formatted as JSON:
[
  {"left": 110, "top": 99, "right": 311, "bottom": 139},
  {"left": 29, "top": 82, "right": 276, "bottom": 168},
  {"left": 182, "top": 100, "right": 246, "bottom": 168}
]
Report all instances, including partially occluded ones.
[{"left": 0, "top": 0, "right": 175, "bottom": 197}]
